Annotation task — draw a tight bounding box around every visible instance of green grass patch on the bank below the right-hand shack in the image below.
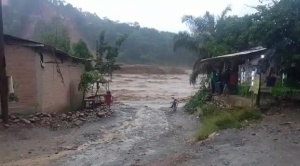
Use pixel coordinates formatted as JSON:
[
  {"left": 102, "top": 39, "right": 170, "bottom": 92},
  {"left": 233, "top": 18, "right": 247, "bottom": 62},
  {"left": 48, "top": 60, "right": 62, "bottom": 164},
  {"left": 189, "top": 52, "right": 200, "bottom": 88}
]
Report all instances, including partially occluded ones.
[{"left": 197, "top": 104, "right": 262, "bottom": 140}]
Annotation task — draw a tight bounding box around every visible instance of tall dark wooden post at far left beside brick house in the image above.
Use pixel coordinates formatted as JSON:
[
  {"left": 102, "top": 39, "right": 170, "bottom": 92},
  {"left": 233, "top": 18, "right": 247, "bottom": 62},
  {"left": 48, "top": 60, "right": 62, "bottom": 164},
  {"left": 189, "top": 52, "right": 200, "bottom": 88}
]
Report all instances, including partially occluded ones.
[{"left": 0, "top": 0, "right": 8, "bottom": 123}]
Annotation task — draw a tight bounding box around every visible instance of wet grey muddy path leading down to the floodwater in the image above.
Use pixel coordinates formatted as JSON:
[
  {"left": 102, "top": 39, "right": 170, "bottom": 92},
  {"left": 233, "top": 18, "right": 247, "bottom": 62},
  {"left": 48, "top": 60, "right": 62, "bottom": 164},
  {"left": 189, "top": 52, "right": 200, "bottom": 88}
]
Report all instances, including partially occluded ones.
[{"left": 51, "top": 103, "right": 198, "bottom": 166}]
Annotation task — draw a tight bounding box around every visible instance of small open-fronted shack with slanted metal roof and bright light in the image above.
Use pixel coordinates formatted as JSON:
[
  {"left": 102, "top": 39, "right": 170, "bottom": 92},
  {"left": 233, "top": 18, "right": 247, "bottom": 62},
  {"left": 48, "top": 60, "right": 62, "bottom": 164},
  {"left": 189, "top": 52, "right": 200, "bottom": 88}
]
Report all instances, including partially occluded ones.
[{"left": 198, "top": 47, "right": 280, "bottom": 95}]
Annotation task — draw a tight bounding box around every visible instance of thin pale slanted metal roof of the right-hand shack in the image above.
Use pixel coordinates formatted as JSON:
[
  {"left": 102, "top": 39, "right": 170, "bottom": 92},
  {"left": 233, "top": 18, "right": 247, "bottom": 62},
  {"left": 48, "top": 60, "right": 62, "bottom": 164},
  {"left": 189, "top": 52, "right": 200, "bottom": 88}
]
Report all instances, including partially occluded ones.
[{"left": 201, "top": 47, "right": 267, "bottom": 62}]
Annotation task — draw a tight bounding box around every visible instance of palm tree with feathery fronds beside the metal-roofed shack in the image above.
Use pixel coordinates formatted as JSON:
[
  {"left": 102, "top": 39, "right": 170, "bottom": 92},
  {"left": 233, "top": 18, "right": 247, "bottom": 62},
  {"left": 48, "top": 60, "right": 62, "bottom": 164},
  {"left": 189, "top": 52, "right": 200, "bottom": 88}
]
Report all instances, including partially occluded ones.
[{"left": 174, "top": 6, "right": 231, "bottom": 84}]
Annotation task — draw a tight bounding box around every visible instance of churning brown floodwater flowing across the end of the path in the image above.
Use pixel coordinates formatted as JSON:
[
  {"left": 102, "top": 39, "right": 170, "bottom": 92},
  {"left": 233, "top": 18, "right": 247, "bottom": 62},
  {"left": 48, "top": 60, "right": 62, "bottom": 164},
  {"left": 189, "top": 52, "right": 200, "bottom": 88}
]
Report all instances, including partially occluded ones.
[{"left": 101, "top": 74, "right": 197, "bottom": 104}]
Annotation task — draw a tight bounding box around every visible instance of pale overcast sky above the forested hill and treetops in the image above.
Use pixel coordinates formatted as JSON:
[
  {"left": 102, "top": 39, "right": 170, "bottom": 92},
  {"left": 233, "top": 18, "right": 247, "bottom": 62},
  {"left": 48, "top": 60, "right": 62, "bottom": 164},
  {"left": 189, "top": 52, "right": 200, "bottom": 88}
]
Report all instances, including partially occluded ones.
[{"left": 66, "top": 0, "right": 258, "bottom": 32}]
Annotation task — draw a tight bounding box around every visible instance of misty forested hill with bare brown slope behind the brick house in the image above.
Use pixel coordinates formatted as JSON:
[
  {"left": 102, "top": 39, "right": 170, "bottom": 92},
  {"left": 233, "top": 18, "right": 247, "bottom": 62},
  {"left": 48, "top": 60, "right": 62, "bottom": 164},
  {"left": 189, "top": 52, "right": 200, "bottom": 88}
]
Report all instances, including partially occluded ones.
[{"left": 3, "top": 0, "right": 194, "bottom": 66}]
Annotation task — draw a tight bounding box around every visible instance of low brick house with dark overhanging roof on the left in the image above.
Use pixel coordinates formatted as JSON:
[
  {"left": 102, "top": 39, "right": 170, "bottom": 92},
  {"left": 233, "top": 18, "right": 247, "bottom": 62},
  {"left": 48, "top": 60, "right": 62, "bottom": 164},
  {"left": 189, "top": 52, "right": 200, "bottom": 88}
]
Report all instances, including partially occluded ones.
[{"left": 4, "top": 35, "right": 85, "bottom": 114}]
